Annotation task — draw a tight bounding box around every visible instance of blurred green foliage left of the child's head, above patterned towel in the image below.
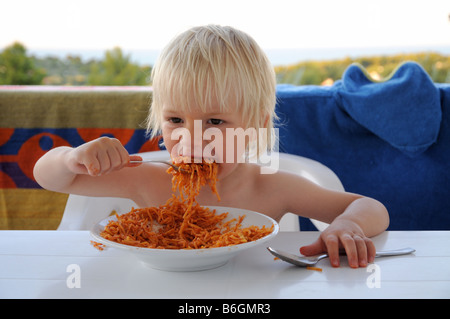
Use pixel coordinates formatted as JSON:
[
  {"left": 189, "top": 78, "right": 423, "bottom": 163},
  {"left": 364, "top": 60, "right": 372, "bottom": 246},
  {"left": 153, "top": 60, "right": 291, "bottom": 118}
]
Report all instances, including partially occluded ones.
[{"left": 0, "top": 43, "right": 151, "bottom": 85}]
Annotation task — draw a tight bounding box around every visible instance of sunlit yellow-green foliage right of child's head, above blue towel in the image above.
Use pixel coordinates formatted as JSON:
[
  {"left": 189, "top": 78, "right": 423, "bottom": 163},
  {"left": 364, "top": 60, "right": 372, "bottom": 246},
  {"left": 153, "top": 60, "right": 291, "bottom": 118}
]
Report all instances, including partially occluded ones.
[{"left": 275, "top": 52, "right": 450, "bottom": 85}]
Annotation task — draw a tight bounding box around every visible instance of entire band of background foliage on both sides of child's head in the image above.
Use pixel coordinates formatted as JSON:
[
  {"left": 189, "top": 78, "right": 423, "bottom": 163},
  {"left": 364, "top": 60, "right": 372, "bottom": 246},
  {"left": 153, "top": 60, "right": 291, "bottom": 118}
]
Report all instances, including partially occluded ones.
[{"left": 0, "top": 43, "right": 450, "bottom": 85}]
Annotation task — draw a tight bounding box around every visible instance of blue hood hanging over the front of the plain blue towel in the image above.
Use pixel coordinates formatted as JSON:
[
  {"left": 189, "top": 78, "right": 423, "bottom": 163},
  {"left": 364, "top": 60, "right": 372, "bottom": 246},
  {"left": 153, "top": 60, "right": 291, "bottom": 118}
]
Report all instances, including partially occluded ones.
[{"left": 335, "top": 62, "right": 442, "bottom": 156}]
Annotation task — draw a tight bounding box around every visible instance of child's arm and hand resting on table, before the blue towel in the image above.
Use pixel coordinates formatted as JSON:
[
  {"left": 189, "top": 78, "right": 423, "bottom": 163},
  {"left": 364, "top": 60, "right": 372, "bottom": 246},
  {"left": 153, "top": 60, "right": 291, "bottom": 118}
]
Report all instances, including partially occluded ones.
[{"left": 281, "top": 174, "right": 389, "bottom": 267}]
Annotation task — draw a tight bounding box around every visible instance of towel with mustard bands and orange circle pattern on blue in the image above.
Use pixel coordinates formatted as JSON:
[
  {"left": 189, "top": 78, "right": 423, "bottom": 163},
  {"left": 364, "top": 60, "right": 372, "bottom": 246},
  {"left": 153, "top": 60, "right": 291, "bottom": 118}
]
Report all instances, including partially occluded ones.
[{"left": 0, "top": 86, "right": 159, "bottom": 229}]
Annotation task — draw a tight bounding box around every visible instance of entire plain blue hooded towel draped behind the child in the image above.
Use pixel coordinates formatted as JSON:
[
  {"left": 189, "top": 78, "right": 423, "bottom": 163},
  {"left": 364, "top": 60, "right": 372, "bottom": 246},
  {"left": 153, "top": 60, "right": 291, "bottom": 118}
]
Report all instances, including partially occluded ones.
[{"left": 276, "top": 63, "right": 450, "bottom": 230}]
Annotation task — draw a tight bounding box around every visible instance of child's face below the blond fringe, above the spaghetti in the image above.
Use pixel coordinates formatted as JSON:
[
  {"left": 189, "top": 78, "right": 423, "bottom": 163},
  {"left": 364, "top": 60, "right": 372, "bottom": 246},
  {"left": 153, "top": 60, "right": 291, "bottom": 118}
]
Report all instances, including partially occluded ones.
[{"left": 161, "top": 95, "right": 256, "bottom": 175}]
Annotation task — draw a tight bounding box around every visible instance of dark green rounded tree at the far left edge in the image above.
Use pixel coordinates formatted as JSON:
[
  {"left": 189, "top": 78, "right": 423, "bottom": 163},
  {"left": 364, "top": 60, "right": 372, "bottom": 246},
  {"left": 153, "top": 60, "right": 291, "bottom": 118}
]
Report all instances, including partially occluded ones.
[{"left": 0, "top": 42, "right": 45, "bottom": 85}]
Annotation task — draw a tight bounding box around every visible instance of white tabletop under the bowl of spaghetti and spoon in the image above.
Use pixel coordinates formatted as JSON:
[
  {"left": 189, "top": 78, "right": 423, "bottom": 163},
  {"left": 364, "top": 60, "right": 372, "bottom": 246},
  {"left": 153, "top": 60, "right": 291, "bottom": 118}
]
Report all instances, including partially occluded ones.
[{"left": 0, "top": 231, "right": 450, "bottom": 299}]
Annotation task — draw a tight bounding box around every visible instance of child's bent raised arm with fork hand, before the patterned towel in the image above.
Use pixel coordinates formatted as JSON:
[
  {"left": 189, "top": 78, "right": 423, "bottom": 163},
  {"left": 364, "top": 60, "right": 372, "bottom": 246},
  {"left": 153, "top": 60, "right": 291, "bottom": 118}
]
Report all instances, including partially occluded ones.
[{"left": 34, "top": 138, "right": 142, "bottom": 197}]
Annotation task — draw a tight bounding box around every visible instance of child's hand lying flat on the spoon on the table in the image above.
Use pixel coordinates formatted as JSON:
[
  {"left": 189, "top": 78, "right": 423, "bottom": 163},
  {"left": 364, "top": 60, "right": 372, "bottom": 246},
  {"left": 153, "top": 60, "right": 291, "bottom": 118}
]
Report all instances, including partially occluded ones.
[{"left": 300, "top": 219, "right": 376, "bottom": 268}]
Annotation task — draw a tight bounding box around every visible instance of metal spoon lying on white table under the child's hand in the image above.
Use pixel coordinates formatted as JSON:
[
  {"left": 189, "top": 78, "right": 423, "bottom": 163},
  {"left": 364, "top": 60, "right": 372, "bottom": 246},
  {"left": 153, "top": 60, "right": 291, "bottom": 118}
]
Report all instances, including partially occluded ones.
[{"left": 267, "top": 247, "right": 416, "bottom": 267}]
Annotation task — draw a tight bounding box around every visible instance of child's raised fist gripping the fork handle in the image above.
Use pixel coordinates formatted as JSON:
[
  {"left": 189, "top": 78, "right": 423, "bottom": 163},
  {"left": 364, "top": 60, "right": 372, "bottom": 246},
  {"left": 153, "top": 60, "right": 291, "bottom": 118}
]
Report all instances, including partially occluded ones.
[{"left": 66, "top": 137, "right": 140, "bottom": 176}]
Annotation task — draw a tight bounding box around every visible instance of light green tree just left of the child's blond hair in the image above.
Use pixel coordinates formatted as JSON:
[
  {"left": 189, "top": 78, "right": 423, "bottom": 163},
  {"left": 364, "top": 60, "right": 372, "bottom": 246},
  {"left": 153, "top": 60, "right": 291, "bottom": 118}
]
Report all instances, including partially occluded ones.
[{"left": 88, "top": 47, "right": 150, "bottom": 85}]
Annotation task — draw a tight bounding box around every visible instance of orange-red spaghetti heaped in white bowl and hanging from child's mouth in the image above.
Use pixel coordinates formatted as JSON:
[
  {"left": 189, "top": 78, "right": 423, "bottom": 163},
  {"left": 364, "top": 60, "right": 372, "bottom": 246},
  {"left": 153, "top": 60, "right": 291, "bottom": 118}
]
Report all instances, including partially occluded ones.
[{"left": 100, "top": 162, "right": 274, "bottom": 249}]
